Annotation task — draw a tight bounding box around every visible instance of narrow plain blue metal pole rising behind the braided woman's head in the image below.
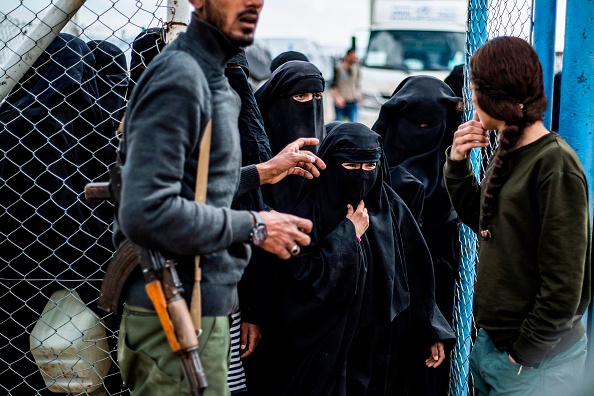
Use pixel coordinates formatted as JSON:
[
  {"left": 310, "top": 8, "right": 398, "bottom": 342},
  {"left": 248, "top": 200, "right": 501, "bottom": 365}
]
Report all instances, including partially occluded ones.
[{"left": 532, "top": 0, "right": 557, "bottom": 129}]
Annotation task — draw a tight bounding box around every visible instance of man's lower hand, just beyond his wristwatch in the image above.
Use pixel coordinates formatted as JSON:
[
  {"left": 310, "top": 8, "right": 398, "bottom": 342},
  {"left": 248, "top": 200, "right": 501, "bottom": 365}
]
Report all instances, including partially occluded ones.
[{"left": 260, "top": 212, "right": 313, "bottom": 260}]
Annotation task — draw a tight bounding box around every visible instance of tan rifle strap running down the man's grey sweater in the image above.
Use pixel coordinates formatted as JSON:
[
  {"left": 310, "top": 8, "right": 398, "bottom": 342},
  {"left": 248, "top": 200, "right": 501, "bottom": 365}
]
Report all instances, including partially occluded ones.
[{"left": 190, "top": 119, "right": 212, "bottom": 334}]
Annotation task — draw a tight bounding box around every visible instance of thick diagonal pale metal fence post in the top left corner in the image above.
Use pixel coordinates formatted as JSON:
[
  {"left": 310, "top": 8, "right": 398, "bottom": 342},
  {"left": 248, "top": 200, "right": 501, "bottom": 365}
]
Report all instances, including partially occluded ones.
[{"left": 0, "top": 0, "right": 86, "bottom": 102}]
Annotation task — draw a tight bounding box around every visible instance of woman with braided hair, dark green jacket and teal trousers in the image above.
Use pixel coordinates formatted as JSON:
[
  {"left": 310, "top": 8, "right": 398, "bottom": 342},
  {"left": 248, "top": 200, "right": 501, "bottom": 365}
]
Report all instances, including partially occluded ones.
[{"left": 444, "top": 37, "right": 591, "bottom": 395}]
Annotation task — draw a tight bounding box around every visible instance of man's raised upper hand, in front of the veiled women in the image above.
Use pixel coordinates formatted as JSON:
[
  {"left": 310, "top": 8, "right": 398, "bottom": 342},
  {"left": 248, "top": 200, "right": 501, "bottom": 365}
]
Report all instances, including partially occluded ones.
[{"left": 256, "top": 138, "right": 326, "bottom": 184}]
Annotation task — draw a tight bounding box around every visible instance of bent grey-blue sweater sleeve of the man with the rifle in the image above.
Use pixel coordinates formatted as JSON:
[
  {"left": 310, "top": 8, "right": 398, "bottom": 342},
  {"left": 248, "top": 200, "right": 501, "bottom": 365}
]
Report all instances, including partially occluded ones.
[{"left": 119, "top": 51, "right": 252, "bottom": 255}]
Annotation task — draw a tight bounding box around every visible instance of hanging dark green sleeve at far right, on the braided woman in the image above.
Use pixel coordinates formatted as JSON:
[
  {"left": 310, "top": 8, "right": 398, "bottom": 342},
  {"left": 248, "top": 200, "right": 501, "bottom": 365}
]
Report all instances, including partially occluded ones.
[{"left": 514, "top": 172, "right": 590, "bottom": 363}]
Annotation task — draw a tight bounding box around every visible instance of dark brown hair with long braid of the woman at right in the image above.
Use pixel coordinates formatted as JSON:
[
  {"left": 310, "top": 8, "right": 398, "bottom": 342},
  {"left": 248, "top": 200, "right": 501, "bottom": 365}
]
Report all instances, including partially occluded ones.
[{"left": 470, "top": 37, "right": 547, "bottom": 240}]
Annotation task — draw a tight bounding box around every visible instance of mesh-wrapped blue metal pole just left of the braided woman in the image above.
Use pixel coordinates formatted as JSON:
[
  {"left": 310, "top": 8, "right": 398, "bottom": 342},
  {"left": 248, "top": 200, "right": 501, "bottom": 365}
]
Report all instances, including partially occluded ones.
[{"left": 450, "top": 0, "right": 489, "bottom": 396}]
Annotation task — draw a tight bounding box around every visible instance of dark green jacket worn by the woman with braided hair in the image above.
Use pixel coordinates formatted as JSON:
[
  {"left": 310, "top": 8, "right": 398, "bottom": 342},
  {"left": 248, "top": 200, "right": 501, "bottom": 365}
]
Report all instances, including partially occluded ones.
[{"left": 444, "top": 133, "right": 591, "bottom": 363}]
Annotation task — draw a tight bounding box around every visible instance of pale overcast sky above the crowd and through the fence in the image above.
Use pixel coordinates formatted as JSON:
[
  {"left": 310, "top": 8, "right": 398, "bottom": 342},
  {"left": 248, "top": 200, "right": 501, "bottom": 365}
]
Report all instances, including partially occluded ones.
[{"left": 0, "top": 0, "right": 565, "bottom": 50}]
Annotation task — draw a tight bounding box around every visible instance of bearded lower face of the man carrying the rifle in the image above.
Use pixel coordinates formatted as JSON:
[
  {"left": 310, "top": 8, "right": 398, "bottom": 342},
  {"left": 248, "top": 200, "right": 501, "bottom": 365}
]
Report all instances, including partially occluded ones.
[{"left": 190, "top": 0, "right": 264, "bottom": 47}]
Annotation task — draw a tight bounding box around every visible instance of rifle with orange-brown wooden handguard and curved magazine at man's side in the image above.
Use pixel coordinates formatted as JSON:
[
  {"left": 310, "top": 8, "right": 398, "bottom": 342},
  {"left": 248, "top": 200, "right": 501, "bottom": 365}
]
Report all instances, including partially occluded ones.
[{"left": 85, "top": 172, "right": 208, "bottom": 396}]
